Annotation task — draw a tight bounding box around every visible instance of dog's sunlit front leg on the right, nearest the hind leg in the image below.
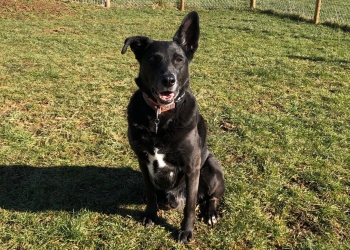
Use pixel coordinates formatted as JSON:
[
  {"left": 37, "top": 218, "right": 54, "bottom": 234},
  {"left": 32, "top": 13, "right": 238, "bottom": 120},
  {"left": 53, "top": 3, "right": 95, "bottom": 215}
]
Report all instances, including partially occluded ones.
[{"left": 178, "top": 168, "right": 199, "bottom": 243}]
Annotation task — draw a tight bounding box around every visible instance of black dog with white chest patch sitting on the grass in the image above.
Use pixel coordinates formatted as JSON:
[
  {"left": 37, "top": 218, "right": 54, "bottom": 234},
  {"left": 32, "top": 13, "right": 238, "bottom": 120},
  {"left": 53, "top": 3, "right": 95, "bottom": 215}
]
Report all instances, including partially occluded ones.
[{"left": 122, "top": 12, "right": 224, "bottom": 242}]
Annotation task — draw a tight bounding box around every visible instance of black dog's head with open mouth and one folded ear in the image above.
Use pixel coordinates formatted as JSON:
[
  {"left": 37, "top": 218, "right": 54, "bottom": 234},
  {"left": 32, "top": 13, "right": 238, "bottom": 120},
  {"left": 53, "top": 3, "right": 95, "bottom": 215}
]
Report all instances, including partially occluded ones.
[{"left": 122, "top": 11, "right": 199, "bottom": 104}]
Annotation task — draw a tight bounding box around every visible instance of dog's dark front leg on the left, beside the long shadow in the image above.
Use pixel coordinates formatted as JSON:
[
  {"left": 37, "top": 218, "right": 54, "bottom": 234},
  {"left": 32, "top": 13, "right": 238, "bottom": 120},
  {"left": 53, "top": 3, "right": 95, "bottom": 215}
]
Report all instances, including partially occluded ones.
[{"left": 139, "top": 161, "right": 158, "bottom": 227}]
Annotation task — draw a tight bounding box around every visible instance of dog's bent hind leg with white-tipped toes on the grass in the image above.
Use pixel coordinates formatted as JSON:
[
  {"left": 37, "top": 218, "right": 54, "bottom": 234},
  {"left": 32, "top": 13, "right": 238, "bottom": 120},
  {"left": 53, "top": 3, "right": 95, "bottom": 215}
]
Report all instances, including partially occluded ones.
[{"left": 198, "top": 153, "right": 225, "bottom": 226}]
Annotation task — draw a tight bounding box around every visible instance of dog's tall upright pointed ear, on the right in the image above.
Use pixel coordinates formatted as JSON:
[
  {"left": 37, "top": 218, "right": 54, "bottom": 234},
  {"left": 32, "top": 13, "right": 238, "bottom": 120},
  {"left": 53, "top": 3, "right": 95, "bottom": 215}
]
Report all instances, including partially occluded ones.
[{"left": 173, "top": 11, "right": 199, "bottom": 60}]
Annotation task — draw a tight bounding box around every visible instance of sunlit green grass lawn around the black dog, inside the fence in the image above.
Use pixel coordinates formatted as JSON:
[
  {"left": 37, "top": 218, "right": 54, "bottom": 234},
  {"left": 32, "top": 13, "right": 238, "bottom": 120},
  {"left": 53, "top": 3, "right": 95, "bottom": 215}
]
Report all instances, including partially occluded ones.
[{"left": 0, "top": 1, "right": 350, "bottom": 249}]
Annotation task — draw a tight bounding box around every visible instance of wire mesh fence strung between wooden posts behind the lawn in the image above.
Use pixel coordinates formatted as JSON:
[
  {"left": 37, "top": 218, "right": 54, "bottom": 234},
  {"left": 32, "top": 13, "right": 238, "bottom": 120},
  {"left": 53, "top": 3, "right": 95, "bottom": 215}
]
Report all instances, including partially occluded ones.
[{"left": 66, "top": 0, "right": 350, "bottom": 25}]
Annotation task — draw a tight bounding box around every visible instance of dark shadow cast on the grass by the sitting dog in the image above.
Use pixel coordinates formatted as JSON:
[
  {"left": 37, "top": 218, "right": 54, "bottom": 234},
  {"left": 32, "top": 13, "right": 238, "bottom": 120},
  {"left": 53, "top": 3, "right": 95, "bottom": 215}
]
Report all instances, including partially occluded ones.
[{"left": 0, "top": 165, "right": 176, "bottom": 231}]
